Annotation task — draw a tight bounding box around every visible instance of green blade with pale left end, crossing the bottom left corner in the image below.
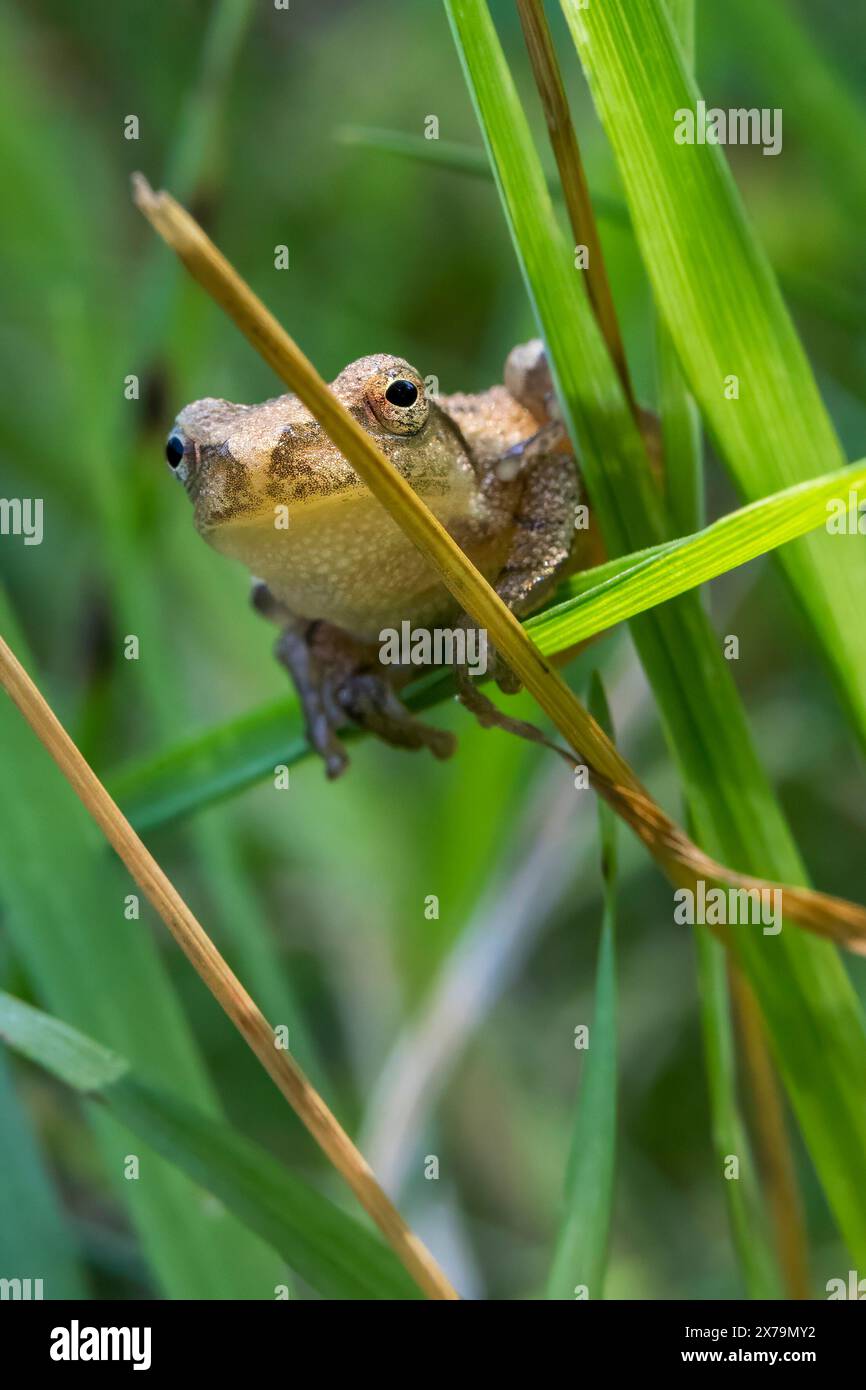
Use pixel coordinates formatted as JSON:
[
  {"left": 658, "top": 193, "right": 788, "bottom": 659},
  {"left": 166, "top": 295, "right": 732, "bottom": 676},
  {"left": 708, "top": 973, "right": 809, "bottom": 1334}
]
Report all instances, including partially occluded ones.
[{"left": 0, "top": 994, "right": 421, "bottom": 1298}]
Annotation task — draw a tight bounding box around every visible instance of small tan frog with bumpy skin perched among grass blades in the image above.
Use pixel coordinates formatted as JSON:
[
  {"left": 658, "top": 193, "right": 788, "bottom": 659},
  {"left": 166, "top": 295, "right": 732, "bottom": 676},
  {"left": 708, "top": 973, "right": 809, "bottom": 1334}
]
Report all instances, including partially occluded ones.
[{"left": 174, "top": 342, "right": 578, "bottom": 776}]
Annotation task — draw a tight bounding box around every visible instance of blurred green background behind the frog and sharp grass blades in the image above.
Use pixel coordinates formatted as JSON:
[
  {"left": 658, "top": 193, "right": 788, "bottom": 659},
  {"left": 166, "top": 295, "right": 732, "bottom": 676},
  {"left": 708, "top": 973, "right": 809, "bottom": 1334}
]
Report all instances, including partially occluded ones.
[{"left": 0, "top": 0, "right": 866, "bottom": 1298}]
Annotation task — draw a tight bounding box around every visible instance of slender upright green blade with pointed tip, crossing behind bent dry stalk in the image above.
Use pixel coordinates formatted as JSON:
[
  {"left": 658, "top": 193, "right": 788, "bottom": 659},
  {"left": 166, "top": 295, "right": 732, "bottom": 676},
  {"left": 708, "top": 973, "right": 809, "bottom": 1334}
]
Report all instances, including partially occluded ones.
[{"left": 548, "top": 674, "right": 617, "bottom": 1300}]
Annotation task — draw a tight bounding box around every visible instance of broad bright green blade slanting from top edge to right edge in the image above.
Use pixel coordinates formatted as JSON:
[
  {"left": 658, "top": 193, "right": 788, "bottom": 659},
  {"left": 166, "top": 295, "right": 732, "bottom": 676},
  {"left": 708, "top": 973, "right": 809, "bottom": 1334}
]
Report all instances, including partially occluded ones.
[{"left": 563, "top": 0, "right": 866, "bottom": 742}]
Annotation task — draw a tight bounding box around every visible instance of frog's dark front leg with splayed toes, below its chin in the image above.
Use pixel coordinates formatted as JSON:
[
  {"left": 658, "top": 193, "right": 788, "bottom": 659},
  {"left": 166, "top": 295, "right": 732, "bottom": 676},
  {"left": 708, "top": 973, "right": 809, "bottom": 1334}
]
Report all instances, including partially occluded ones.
[{"left": 252, "top": 580, "right": 456, "bottom": 778}]
